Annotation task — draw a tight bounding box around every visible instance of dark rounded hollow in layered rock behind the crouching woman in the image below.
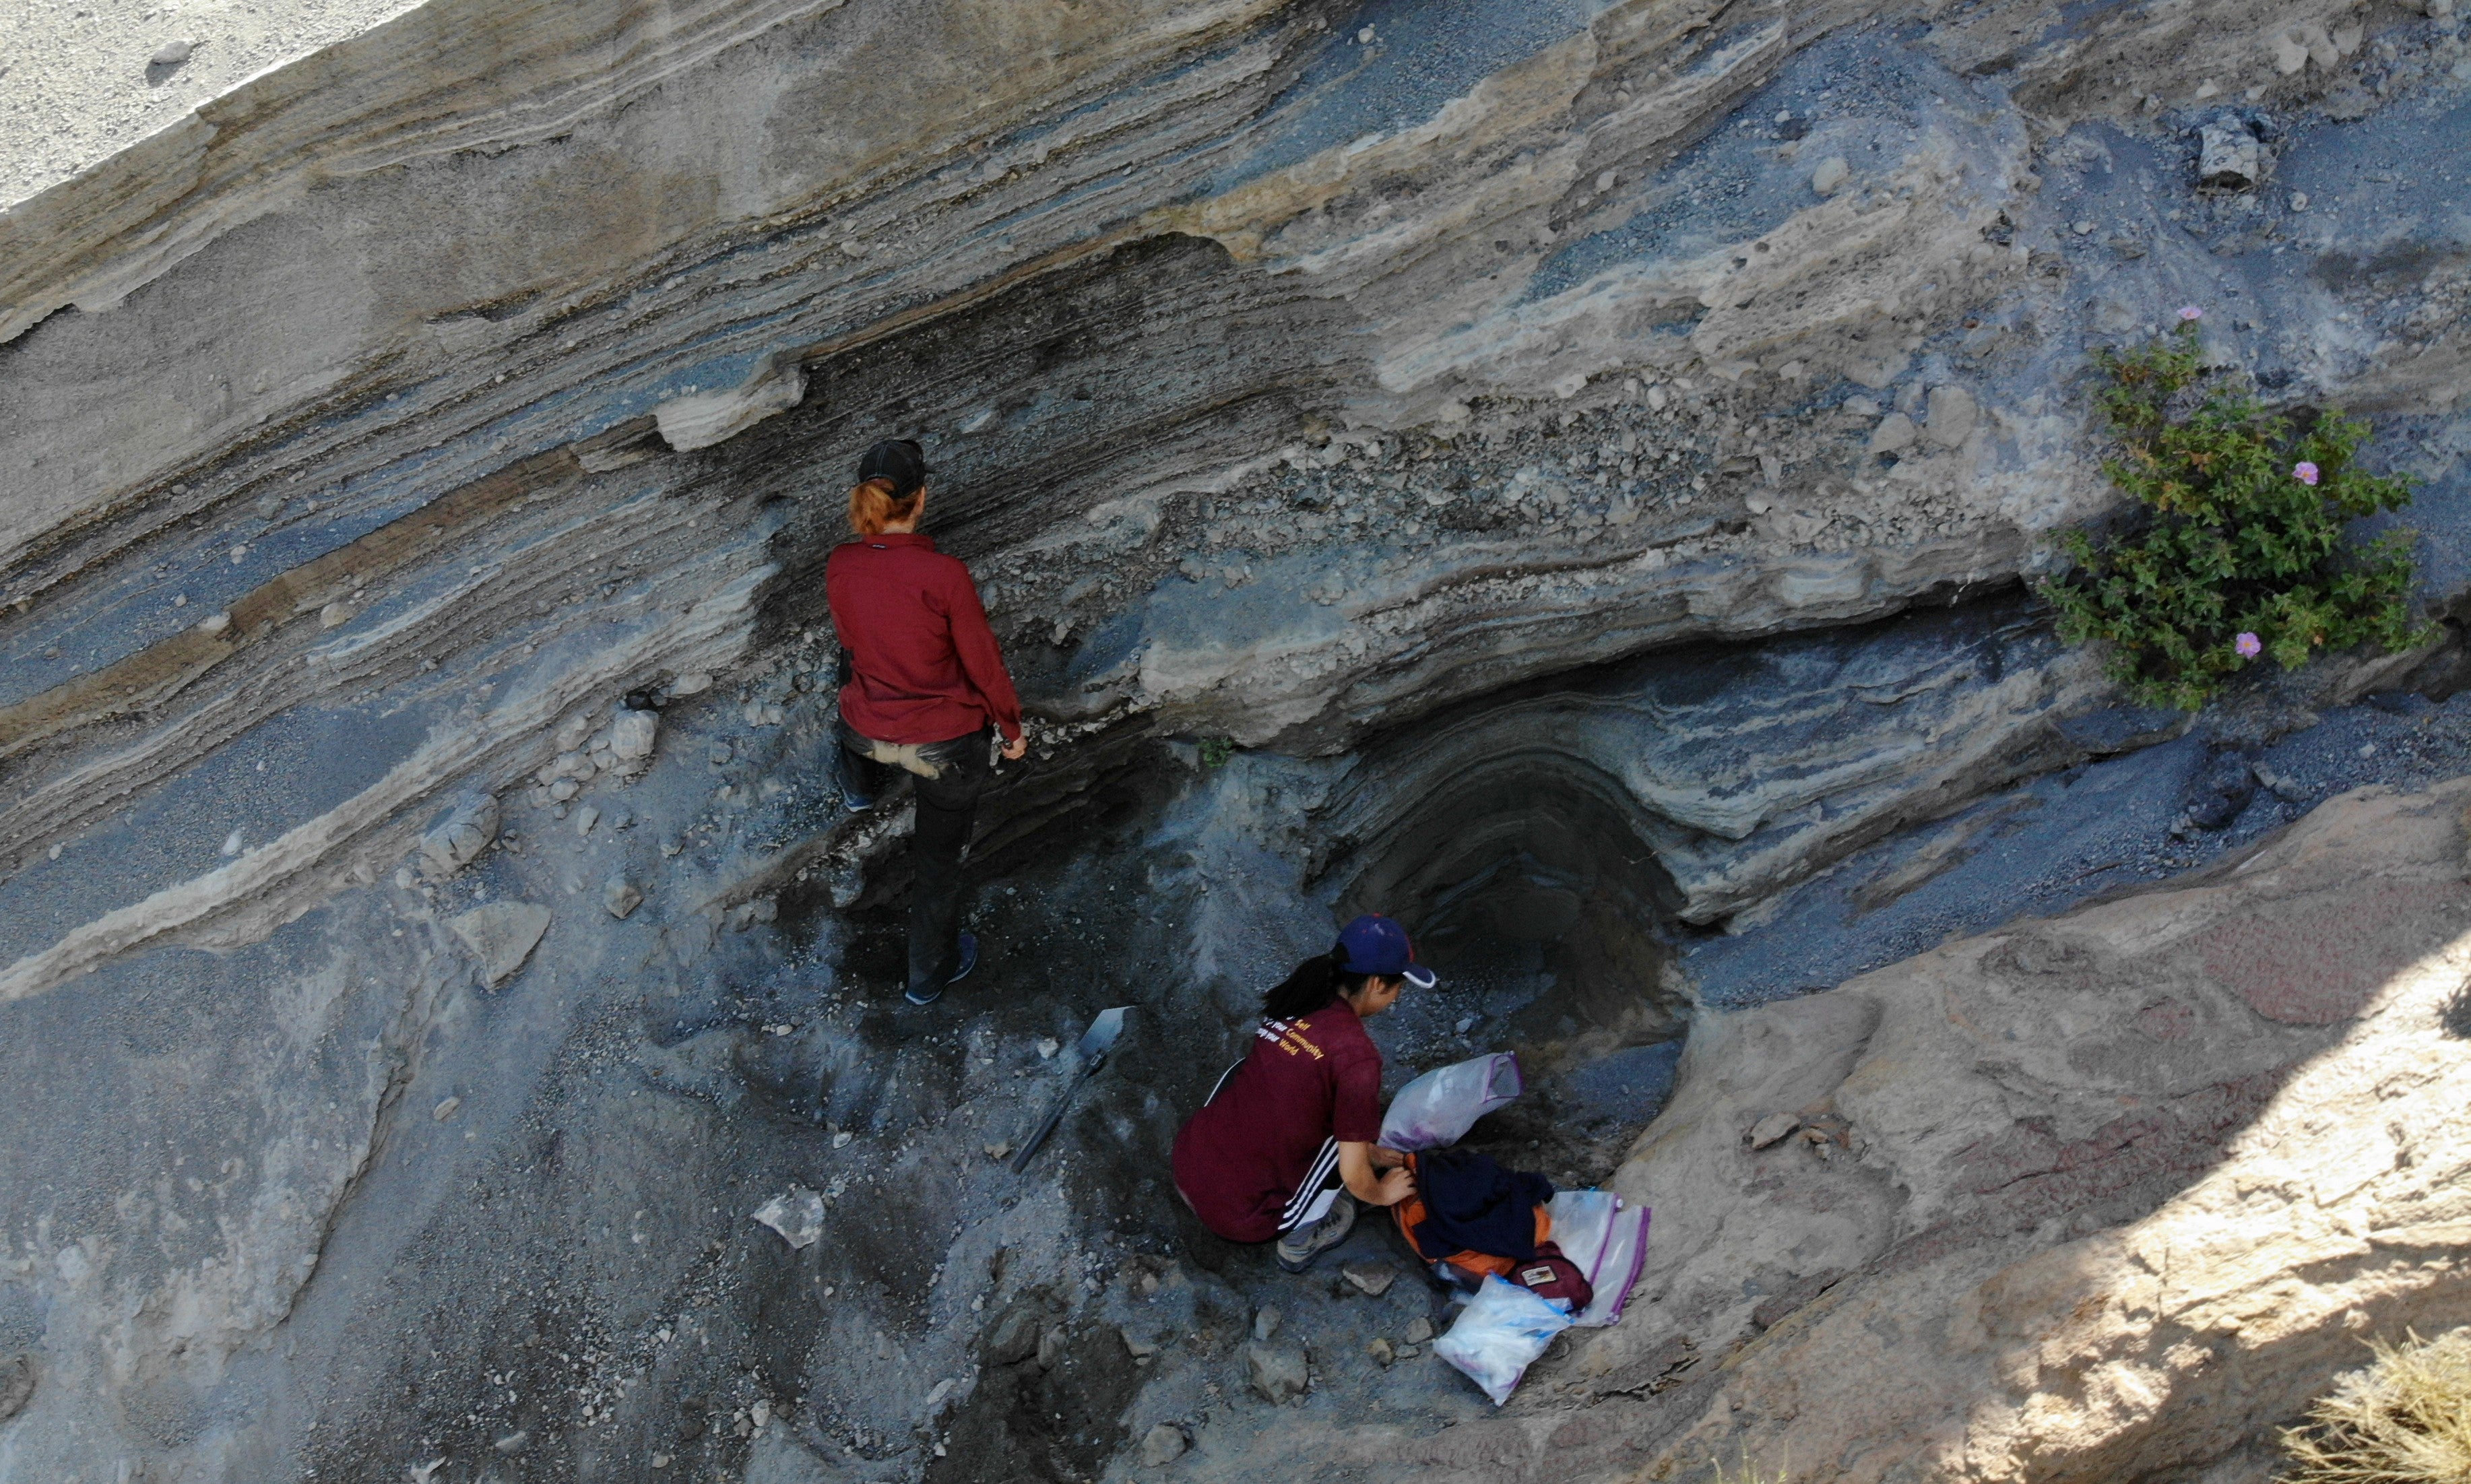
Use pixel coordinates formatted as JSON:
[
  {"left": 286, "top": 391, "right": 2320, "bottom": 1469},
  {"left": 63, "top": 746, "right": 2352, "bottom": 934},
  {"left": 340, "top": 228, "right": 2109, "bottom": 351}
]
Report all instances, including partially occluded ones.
[{"left": 1327, "top": 746, "right": 1690, "bottom": 1183}]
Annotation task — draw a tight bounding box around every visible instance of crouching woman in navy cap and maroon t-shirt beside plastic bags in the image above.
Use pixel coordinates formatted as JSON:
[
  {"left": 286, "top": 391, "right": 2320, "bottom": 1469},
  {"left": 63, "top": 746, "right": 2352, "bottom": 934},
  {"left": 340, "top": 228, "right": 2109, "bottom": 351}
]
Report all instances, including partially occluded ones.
[{"left": 1174, "top": 913, "right": 1433, "bottom": 1272}]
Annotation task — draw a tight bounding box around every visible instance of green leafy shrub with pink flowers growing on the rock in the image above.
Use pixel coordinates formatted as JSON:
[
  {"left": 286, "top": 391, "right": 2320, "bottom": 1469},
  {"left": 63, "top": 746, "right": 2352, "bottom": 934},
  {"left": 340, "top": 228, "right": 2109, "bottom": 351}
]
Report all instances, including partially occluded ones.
[{"left": 2041, "top": 311, "right": 2427, "bottom": 711}]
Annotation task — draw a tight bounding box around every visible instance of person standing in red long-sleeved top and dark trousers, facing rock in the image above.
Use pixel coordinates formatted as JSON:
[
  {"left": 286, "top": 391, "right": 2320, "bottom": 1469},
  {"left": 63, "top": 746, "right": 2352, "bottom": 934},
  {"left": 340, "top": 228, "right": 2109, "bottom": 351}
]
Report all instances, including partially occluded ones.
[{"left": 823, "top": 439, "right": 1028, "bottom": 1005}]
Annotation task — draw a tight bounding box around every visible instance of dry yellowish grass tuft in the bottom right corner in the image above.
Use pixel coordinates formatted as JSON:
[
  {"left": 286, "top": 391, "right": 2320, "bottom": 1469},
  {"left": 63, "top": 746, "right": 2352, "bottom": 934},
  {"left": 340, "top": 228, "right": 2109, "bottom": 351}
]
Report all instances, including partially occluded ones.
[{"left": 2283, "top": 1326, "right": 2471, "bottom": 1484}]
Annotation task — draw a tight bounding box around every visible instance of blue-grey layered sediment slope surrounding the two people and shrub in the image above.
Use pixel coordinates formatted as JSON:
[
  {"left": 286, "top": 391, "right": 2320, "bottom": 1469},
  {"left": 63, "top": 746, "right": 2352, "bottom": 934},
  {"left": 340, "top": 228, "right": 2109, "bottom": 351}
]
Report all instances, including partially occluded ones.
[{"left": 0, "top": 0, "right": 2471, "bottom": 1484}]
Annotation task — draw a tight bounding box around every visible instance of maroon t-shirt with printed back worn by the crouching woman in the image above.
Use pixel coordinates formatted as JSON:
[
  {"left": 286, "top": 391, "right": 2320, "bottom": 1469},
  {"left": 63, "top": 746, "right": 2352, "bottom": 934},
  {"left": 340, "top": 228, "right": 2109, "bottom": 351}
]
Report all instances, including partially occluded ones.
[{"left": 1176, "top": 1000, "right": 1381, "bottom": 1242}]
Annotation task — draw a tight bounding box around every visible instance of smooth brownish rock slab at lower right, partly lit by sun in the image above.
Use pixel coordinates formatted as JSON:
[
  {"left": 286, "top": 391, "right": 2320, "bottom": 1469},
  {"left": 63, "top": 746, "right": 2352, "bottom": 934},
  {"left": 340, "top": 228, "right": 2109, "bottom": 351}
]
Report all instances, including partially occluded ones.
[{"left": 1366, "top": 783, "right": 2471, "bottom": 1481}]
